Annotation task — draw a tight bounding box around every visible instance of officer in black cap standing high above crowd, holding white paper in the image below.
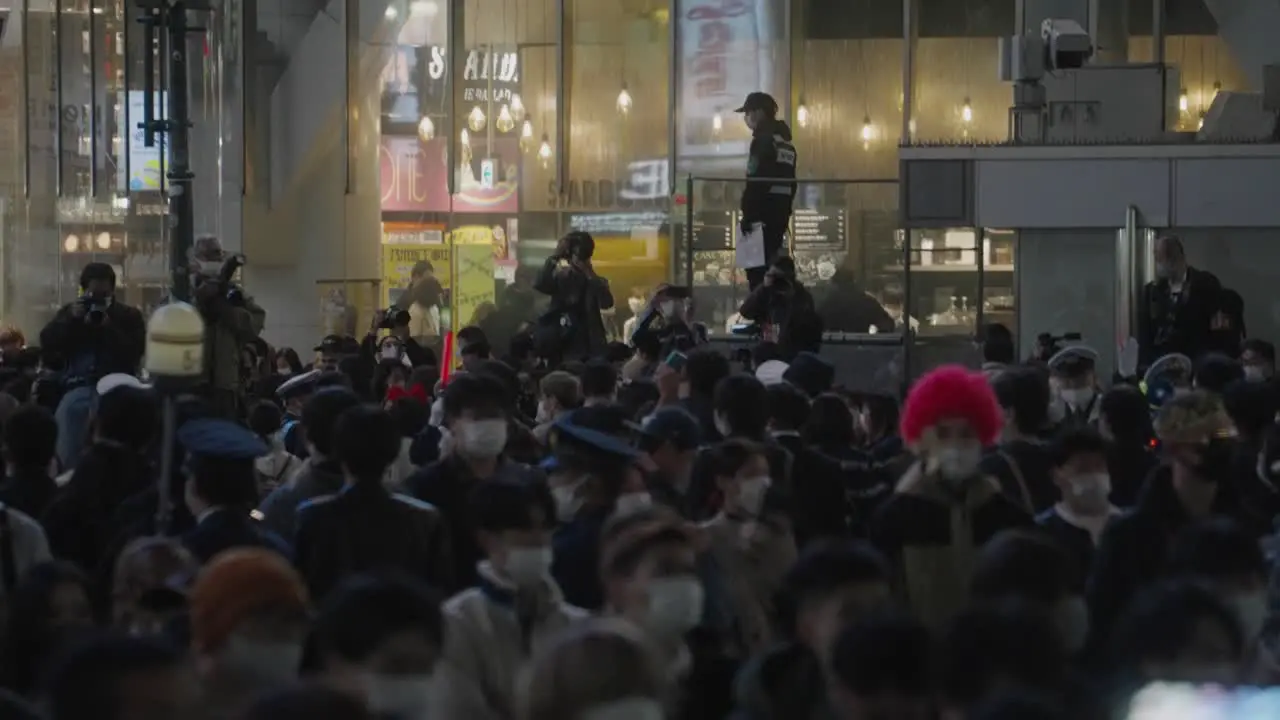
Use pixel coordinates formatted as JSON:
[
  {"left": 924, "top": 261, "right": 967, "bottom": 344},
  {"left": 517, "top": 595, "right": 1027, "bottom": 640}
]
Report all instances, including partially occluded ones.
[{"left": 736, "top": 92, "right": 796, "bottom": 290}]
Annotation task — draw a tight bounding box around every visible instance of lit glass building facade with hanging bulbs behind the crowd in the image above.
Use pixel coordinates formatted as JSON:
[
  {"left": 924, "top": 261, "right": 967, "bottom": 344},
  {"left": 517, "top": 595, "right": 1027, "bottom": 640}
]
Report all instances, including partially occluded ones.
[{"left": 0, "top": 0, "right": 1257, "bottom": 358}]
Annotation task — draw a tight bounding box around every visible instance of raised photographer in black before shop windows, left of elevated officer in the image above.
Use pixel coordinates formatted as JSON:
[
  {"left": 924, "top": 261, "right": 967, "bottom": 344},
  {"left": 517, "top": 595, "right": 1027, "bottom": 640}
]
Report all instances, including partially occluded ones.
[{"left": 534, "top": 231, "right": 613, "bottom": 360}]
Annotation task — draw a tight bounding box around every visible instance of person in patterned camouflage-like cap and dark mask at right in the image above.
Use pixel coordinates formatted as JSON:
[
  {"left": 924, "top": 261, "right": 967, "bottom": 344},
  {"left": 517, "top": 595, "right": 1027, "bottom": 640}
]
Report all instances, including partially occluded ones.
[{"left": 1088, "top": 391, "right": 1242, "bottom": 648}]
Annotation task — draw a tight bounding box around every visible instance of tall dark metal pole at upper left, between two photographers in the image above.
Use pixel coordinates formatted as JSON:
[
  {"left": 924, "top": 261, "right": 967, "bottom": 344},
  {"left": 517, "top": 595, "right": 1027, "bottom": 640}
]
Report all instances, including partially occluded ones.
[{"left": 165, "top": 0, "right": 196, "bottom": 302}]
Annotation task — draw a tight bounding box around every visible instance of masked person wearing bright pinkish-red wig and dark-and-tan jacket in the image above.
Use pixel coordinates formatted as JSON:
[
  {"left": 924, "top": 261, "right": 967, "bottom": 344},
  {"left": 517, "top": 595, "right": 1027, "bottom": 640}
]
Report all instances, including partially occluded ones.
[{"left": 870, "top": 365, "right": 1032, "bottom": 624}]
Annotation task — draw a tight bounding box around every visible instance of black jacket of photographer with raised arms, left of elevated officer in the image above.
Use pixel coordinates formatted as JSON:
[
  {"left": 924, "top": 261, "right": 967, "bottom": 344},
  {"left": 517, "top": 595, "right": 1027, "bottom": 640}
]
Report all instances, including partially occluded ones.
[{"left": 534, "top": 256, "right": 613, "bottom": 360}]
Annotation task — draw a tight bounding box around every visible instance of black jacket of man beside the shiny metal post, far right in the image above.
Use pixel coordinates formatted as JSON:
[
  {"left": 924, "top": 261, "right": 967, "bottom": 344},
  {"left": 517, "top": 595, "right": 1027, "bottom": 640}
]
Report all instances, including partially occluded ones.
[{"left": 1138, "top": 268, "right": 1222, "bottom": 368}]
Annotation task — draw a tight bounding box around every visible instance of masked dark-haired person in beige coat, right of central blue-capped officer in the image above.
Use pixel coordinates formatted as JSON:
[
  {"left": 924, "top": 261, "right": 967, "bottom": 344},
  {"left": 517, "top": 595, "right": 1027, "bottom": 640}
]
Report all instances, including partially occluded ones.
[{"left": 701, "top": 439, "right": 796, "bottom": 657}]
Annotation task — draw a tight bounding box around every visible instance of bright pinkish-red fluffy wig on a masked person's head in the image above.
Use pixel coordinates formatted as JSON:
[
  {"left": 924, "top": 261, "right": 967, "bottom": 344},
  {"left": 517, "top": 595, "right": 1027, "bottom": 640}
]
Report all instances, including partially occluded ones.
[{"left": 901, "top": 365, "right": 1005, "bottom": 446}]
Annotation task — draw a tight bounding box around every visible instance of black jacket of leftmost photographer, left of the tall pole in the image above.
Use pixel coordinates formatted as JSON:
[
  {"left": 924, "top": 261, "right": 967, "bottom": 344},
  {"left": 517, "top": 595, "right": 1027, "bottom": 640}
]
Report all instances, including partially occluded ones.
[{"left": 40, "top": 300, "right": 147, "bottom": 382}]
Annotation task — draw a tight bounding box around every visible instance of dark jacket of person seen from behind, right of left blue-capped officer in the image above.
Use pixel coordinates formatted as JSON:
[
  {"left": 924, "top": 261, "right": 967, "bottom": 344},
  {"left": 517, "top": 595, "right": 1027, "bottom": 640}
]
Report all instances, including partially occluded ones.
[{"left": 293, "top": 483, "right": 453, "bottom": 597}]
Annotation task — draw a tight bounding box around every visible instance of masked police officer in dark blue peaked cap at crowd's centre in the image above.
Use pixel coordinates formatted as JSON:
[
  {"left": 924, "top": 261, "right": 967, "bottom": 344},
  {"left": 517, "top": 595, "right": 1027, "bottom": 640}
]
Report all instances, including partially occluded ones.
[{"left": 548, "top": 406, "right": 648, "bottom": 611}]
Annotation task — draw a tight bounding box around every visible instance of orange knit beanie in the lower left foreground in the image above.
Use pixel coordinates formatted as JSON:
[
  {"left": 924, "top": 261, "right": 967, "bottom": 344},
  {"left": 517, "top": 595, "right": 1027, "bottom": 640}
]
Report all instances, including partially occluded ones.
[{"left": 188, "top": 548, "right": 307, "bottom": 653}]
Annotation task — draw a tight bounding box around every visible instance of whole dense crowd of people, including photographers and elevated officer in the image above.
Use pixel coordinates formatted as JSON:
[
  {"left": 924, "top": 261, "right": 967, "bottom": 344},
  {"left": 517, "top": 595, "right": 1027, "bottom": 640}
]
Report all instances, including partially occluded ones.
[{"left": 0, "top": 88, "right": 1264, "bottom": 720}]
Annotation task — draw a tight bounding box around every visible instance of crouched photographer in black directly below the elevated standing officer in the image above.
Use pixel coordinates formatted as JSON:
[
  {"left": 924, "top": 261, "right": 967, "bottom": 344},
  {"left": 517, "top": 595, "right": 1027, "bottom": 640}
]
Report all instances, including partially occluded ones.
[{"left": 737, "top": 255, "right": 822, "bottom": 363}]
